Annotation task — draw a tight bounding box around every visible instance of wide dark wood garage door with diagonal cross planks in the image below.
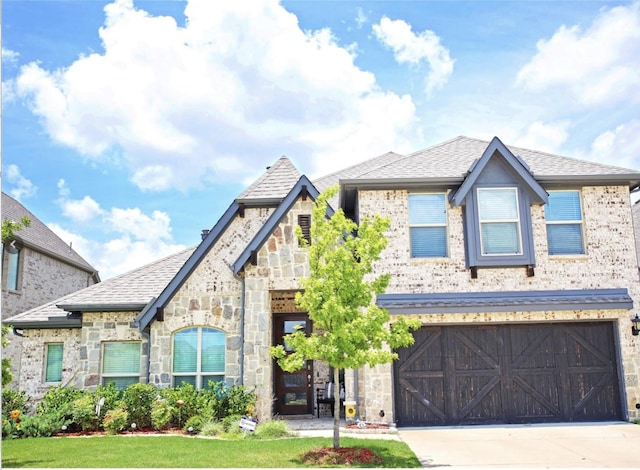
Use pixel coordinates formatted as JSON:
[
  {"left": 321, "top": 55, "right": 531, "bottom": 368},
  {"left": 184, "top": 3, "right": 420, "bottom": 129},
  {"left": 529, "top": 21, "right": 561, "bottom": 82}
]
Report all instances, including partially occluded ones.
[{"left": 394, "top": 322, "right": 622, "bottom": 426}]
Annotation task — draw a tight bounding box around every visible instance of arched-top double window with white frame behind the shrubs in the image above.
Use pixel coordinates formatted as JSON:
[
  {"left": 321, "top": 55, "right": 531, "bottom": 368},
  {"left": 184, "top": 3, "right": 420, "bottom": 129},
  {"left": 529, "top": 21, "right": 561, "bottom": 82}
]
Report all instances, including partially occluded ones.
[{"left": 173, "top": 327, "right": 226, "bottom": 389}]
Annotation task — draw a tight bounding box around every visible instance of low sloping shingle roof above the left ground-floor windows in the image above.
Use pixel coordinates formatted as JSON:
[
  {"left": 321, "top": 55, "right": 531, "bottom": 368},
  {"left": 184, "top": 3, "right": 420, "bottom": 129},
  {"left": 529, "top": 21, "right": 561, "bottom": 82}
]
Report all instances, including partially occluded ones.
[{"left": 5, "top": 248, "right": 195, "bottom": 327}]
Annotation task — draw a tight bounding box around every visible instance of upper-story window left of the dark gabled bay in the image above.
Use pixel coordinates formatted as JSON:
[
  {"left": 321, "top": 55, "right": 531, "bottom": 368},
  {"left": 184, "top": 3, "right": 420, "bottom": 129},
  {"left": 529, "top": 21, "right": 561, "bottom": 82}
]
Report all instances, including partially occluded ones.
[{"left": 409, "top": 193, "right": 448, "bottom": 258}]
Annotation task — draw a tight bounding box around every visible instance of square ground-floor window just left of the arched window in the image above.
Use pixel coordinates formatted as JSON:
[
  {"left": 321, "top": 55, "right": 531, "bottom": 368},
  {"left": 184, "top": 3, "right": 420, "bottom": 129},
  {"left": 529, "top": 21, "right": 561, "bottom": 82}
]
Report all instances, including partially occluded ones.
[{"left": 102, "top": 341, "right": 140, "bottom": 390}]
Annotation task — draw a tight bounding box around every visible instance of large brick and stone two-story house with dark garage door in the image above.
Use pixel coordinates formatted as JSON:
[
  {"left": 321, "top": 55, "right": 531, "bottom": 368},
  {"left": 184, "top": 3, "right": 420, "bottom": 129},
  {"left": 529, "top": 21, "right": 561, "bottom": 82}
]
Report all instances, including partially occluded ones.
[{"left": 5, "top": 137, "right": 640, "bottom": 426}]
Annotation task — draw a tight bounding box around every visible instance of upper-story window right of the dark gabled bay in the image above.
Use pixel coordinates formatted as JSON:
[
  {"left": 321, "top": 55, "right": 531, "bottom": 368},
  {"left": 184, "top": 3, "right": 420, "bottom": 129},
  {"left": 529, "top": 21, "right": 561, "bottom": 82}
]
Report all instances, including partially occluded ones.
[{"left": 544, "top": 191, "right": 585, "bottom": 255}]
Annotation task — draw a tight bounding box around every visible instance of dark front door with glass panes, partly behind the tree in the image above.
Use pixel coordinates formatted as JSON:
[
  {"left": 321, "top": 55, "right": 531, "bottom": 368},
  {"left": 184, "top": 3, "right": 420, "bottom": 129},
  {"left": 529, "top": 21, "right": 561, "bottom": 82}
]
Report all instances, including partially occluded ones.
[{"left": 273, "top": 313, "right": 313, "bottom": 415}]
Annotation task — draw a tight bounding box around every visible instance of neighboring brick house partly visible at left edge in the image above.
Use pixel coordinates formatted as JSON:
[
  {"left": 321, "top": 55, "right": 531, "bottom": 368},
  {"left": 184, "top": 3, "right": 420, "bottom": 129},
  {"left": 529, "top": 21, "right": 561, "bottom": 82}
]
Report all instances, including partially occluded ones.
[{"left": 1, "top": 193, "right": 100, "bottom": 386}]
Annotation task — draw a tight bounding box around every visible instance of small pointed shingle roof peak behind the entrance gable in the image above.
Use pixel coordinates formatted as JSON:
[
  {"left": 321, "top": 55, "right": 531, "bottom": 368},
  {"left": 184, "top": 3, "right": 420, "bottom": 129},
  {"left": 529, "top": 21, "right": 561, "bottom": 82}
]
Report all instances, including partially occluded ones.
[{"left": 236, "top": 156, "right": 301, "bottom": 202}]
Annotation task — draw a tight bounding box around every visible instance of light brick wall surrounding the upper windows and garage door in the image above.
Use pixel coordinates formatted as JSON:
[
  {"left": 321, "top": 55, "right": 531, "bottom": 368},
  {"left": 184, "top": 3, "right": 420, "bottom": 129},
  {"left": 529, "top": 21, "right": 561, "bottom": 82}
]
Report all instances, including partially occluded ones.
[{"left": 358, "top": 186, "right": 640, "bottom": 422}]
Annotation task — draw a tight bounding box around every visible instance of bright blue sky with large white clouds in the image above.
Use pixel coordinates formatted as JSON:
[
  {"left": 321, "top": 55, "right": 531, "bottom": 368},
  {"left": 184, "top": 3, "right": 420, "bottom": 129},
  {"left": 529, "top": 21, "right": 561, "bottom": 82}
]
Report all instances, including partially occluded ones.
[{"left": 2, "top": 0, "right": 640, "bottom": 279}]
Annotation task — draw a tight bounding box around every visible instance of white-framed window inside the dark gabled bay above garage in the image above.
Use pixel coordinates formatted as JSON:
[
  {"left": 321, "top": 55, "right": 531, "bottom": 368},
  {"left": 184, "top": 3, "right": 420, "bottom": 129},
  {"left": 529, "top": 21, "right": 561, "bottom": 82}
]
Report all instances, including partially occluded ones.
[{"left": 477, "top": 188, "right": 522, "bottom": 256}]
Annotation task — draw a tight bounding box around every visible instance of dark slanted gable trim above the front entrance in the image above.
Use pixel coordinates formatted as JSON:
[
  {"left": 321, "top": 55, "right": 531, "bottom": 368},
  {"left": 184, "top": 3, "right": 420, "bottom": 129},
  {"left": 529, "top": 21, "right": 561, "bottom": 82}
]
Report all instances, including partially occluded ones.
[{"left": 232, "top": 175, "right": 333, "bottom": 275}]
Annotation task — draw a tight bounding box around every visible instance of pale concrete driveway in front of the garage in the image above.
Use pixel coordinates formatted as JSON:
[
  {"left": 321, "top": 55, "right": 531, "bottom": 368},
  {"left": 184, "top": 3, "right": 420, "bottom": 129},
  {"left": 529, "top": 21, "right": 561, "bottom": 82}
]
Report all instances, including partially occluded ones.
[{"left": 399, "top": 422, "right": 640, "bottom": 468}]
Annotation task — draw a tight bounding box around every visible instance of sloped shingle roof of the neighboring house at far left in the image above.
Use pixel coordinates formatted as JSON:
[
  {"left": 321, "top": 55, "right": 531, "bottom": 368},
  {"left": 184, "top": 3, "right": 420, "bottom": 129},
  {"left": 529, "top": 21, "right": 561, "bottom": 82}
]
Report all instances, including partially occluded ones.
[{"left": 2, "top": 192, "right": 96, "bottom": 273}]
